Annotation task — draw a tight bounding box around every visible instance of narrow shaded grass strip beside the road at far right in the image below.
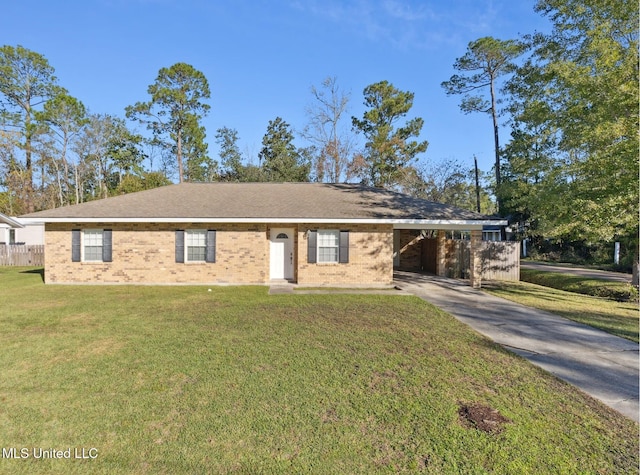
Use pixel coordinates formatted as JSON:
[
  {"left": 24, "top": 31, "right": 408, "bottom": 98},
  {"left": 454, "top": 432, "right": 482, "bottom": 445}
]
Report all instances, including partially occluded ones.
[{"left": 520, "top": 269, "right": 638, "bottom": 302}]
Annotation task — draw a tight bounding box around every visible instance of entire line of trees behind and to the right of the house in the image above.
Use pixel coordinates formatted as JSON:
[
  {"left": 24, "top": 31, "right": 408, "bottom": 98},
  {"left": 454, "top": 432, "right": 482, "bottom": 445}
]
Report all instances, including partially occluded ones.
[{"left": 0, "top": 0, "right": 639, "bottom": 276}]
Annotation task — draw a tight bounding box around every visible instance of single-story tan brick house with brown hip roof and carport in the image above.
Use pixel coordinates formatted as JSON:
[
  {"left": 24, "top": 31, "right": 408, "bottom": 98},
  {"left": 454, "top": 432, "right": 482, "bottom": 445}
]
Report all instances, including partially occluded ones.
[{"left": 19, "top": 183, "right": 505, "bottom": 286}]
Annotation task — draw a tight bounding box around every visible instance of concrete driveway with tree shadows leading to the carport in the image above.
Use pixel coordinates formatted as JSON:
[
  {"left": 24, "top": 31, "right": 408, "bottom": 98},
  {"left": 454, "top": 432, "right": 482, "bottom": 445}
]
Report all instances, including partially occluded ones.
[{"left": 394, "top": 272, "right": 640, "bottom": 422}]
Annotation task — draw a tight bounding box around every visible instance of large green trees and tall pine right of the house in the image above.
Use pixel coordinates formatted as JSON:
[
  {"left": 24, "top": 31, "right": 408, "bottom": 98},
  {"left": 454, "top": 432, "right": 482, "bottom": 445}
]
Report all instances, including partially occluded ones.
[{"left": 442, "top": 0, "right": 640, "bottom": 276}]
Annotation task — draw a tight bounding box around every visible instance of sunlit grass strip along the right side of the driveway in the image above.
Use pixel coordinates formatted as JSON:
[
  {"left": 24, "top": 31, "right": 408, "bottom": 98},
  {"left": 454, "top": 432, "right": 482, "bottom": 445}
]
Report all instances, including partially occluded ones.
[{"left": 483, "top": 282, "right": 640, "bottom": 342}]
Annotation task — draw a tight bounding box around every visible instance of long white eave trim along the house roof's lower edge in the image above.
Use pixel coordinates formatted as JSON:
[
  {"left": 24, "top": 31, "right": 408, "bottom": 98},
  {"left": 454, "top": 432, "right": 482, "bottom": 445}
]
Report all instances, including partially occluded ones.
[{"left": 21, "top": 217, "right": 507, "bottom": 230}]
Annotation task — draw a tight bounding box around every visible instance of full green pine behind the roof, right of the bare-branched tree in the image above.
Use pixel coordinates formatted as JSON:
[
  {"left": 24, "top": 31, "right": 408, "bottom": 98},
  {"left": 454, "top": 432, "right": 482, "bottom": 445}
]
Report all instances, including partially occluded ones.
[{"left": 351, "top": 81, "right": 428, "bottom": 188}]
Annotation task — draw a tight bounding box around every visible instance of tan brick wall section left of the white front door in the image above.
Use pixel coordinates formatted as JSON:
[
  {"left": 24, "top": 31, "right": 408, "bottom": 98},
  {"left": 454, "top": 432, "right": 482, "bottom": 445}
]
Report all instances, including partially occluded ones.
[{"left": 45, "top": 223, "right": 269, "bottom": 284}]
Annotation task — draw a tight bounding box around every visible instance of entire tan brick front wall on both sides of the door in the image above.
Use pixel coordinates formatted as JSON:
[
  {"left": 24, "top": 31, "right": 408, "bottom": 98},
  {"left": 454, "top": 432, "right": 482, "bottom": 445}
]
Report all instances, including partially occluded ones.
[{"left": 45, "top": 223, "right": 393, "bottom": 286}]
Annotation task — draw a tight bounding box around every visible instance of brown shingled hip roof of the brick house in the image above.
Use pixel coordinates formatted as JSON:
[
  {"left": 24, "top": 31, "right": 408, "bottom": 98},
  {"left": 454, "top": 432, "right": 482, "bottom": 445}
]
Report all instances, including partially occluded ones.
[{"left": 21, "top": 183, "right": 506, "bottom": 226}]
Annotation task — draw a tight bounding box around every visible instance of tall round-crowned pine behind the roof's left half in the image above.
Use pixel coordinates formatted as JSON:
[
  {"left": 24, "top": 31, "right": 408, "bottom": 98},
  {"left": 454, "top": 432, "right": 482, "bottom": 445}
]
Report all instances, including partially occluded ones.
[{"left": 126, "top": 63, "right": 210, "bottom": 183}]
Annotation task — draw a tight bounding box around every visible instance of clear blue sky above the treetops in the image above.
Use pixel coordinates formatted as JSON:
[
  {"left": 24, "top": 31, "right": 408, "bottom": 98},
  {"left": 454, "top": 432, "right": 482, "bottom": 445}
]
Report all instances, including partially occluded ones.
[{"left": 0, "top": 0, "right": 549, "bottom": 177}]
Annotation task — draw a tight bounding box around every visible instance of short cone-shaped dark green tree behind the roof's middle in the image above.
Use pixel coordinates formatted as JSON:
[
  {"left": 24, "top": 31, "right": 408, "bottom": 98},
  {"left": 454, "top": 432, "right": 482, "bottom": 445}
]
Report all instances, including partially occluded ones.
[{"left": 258, "top": 117, "right": 311, "bottom": 182}]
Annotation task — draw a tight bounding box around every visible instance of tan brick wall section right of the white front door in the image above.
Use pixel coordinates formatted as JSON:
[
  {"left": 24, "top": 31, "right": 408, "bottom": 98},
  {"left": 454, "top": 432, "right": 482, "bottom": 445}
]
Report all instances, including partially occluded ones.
[{"left": 297, "top": 224, "right": 393, "bottom": 286}]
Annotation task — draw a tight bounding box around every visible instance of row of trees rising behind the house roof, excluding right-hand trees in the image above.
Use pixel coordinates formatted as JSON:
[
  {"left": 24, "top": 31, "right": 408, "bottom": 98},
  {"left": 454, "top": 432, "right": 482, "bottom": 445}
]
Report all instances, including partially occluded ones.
[{"left": 0, "top": 50, "right": 492, "bottom": 215}]
